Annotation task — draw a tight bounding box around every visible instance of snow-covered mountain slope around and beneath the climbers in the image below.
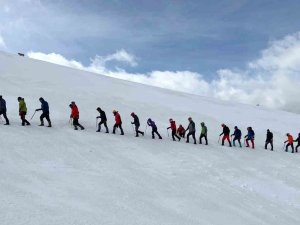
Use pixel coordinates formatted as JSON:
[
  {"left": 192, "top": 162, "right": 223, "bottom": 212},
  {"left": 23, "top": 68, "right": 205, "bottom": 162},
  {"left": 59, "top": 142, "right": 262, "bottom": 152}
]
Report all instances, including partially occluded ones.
[{"left": 0, "top": 53, "right": 300, "bottom": 225}]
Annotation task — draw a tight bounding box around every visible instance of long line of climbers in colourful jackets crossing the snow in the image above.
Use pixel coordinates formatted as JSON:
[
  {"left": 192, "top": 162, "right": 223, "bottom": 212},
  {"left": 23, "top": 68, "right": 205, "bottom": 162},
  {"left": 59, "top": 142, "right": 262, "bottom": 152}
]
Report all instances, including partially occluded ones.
[{"left": 0, "top": 95, "right": 300, "bottom": 153}]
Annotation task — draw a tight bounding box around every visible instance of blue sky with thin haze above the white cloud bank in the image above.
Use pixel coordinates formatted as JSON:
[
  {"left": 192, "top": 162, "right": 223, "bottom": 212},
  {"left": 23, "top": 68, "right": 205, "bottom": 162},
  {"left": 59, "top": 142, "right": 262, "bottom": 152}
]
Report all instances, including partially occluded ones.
[{"left": 0, "top": 0, "right": 300, "bottom": 75}]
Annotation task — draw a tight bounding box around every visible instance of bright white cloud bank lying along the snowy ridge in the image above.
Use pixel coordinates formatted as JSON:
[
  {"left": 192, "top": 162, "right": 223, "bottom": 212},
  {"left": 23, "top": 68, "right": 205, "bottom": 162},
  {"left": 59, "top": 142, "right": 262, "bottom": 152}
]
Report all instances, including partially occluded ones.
[{"left": 29, "top": 32, "right": 300, "bottom": 112}]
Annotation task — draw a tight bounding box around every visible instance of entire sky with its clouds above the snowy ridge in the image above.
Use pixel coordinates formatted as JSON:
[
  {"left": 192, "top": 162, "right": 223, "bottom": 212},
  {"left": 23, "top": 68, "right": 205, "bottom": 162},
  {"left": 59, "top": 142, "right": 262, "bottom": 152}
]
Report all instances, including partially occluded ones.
[{"left": 0, "top": 0, "right": 300, "bottom": 113}]
